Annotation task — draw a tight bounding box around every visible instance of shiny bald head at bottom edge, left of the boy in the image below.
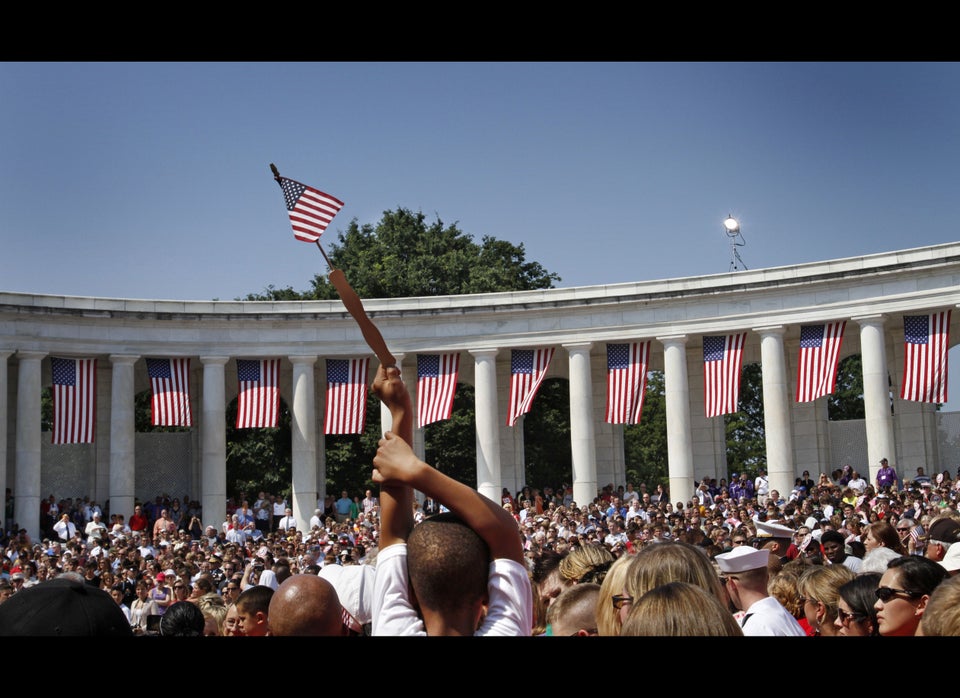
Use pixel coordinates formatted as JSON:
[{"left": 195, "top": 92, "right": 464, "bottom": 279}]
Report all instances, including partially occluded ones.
[{"left": 268, "top": 574, "right": 344, "bottom": 636}]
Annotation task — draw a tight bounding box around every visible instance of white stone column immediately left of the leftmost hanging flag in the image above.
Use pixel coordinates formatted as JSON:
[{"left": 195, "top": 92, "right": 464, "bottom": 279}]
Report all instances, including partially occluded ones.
[{"left": 12, "top": 351, "right": 46, "bottom": 541}]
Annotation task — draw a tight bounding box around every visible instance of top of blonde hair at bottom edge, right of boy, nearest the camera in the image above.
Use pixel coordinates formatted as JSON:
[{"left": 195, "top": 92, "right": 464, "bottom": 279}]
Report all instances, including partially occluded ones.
[{"left": 620, "top": 582, "right": 743, "bottom": 637}]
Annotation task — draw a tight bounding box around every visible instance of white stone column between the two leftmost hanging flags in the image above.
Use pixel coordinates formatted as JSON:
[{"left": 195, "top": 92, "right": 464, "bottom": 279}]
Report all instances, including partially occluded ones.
[{"left": 105, "top": 354, "right": 140, "bottom": 523}]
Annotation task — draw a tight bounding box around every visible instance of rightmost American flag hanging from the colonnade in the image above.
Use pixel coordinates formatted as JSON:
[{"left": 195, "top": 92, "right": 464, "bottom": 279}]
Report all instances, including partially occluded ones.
[{"left": 900, "top": 310, "right": 951, "bottom": 403}]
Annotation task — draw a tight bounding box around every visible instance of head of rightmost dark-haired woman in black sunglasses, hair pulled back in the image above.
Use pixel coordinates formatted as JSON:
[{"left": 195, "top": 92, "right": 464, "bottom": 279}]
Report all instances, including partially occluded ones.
[{"left": 874, "top": 555, "right": 949, "bottom": 637}]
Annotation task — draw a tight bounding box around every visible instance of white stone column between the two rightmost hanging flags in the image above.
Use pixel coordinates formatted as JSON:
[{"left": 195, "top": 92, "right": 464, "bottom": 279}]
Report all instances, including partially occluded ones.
[{"left": 853, "top": 315, "right": 896, "bottom": 484}]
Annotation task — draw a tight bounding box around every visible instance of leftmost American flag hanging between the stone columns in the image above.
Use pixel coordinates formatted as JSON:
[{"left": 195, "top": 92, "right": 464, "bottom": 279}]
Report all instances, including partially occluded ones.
[{"left": 50, "top": 357, "right": 97, "bottom": 444}]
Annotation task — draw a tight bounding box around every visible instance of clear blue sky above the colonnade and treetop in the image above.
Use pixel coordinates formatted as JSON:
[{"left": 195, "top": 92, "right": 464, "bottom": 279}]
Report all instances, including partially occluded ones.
[{"left": 0, "top": 62, "right": 960, "bottom": 406}]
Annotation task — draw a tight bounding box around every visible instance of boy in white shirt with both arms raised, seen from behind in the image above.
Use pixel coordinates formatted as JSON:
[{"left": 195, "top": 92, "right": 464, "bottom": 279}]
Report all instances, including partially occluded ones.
[{"left": 372, "top": 365, "right": 533, "bottom": 636}]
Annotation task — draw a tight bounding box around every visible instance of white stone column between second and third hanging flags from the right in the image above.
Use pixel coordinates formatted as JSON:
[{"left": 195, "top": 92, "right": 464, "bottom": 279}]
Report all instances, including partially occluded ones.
[{"left": 754, "top": 325, "right": 796, "bottom": 496}]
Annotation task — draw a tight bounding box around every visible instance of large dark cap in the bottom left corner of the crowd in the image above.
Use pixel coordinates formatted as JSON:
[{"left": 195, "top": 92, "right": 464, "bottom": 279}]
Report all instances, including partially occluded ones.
[{"left": 0, "top": 577, "right": 133, "bottom": 637}]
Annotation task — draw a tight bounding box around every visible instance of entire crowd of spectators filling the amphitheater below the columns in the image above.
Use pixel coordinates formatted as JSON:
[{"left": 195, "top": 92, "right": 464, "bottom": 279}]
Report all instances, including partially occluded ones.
[{"left": 0, "top": 367, "right": 960, "bottom": 637}]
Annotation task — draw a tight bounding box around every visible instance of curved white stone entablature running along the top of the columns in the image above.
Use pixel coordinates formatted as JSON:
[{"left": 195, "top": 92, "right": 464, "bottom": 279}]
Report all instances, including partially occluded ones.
[{"left": 0, "top": 243, "right": 960, "bottom": 357}]
